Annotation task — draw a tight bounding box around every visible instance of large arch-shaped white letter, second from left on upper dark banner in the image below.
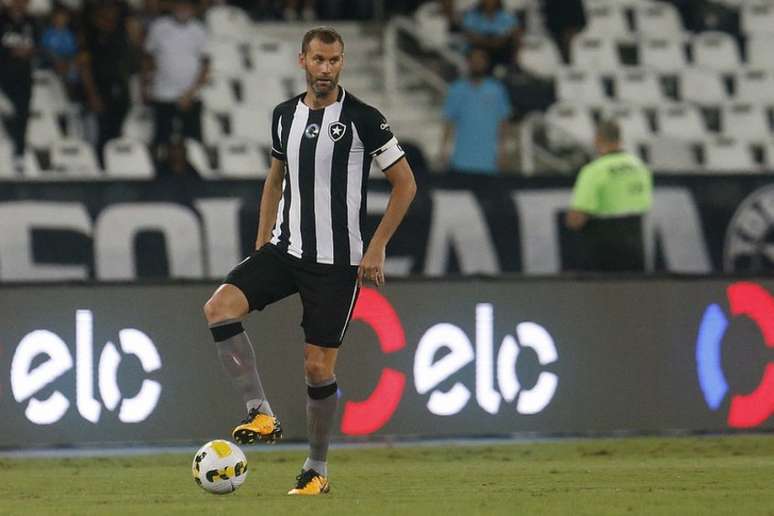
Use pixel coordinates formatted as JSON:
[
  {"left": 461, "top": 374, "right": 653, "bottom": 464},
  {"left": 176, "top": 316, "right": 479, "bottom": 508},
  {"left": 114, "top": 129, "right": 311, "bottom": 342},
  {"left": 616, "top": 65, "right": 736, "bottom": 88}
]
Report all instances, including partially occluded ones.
[{"left": 94, "top": 203, "right": 204, "bottom": 280}]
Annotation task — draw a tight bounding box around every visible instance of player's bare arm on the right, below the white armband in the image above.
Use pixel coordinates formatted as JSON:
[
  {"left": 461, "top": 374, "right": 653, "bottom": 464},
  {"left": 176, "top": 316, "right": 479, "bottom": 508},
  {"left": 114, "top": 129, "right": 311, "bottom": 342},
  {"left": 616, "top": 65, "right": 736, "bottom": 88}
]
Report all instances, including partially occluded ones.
[{"left": 357, "top": 156, "right": 417, "bottom": 287}]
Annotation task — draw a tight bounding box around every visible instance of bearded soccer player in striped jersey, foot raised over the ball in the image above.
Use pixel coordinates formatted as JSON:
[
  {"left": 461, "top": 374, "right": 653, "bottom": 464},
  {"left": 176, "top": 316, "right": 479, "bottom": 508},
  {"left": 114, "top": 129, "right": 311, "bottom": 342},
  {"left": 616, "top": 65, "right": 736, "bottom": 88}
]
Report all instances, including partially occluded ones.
[{"left": 204, "top": 27, "right": 416, "bottom": 495}]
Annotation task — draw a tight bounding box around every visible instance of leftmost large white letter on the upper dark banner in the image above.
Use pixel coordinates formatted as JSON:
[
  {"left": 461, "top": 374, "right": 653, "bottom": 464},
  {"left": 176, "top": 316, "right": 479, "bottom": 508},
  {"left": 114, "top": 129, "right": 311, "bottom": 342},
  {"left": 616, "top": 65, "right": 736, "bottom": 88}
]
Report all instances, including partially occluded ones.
[{"left": 0, "top": 201, "right": 91, "bottom": 281}]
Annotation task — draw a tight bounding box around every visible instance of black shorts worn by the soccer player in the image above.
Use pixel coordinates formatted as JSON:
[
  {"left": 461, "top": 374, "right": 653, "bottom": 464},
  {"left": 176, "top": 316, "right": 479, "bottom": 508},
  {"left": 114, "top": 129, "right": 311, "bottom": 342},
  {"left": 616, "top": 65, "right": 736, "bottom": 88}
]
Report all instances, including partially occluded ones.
[{"left": 225, "top": 244, "right": 360, "bottom": 348}]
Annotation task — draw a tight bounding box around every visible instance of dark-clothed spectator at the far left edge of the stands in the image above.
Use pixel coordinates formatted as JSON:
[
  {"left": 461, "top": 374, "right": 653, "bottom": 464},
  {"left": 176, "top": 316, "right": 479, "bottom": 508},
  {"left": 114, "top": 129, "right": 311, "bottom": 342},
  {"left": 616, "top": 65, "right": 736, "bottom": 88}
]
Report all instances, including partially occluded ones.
[{"left": 0, "top": 0, "right": 37, "bottom": 167}]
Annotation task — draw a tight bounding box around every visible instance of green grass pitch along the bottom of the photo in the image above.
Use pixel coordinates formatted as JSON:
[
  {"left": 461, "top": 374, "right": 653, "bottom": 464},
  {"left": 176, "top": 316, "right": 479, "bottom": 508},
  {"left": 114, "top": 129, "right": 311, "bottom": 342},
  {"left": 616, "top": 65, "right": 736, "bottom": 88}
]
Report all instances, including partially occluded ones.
[{"left": 0, "top": 436, "right": 774, "bottom": 516}]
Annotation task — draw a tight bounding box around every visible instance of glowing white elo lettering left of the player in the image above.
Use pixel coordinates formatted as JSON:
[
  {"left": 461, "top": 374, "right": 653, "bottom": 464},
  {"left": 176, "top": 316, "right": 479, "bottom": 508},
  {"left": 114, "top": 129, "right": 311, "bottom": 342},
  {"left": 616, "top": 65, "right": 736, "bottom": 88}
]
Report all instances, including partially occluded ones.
[{"left": 11, "top": 310, "right": 161, "bottom": 425}]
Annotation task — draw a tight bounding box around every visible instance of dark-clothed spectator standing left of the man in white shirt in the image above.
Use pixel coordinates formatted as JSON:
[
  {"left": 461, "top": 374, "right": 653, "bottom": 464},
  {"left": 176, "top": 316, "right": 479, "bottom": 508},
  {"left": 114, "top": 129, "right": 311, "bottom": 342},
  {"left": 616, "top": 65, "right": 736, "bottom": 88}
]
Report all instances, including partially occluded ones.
[{"left": 78, "top": 0, "right": 136, "bottom": 159}]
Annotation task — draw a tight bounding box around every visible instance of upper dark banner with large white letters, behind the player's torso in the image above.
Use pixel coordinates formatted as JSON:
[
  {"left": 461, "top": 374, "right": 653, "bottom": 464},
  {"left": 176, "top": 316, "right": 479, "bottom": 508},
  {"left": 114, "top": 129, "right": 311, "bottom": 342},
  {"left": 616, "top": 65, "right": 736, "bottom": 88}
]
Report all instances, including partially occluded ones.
[{"left": 0, "top": 175, "right": 774, "bottom": 283}]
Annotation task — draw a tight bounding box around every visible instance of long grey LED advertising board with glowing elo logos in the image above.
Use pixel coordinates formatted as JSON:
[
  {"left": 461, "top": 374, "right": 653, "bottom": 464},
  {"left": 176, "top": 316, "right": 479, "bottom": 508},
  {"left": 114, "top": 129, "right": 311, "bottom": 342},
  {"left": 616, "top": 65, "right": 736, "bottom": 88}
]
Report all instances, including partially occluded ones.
[{"left": 0, "top": 278, "right": 774, "bottom": 447}]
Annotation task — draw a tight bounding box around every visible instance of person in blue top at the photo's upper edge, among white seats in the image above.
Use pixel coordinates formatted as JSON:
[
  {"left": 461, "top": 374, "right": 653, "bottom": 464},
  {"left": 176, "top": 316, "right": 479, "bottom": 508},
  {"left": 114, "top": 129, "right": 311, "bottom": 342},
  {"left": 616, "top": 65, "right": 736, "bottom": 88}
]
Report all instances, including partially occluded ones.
[{"left": 462, "top": 0, "right": 519, "bottom": 66}]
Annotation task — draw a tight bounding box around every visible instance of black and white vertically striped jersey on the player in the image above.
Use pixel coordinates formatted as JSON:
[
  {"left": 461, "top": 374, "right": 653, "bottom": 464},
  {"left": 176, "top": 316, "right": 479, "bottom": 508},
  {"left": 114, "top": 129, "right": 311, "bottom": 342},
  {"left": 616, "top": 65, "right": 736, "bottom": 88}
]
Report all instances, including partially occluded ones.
[{"left": 271, "top": 87, "right": 404, "bottom": 265}]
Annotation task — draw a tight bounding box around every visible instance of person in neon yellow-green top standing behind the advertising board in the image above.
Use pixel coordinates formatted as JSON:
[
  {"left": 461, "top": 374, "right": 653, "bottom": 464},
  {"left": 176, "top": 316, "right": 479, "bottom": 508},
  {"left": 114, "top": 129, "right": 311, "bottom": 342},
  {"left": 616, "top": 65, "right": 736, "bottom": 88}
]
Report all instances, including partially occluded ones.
[{"left": 566, "top": 121, "right": 653, "bottom": 272}]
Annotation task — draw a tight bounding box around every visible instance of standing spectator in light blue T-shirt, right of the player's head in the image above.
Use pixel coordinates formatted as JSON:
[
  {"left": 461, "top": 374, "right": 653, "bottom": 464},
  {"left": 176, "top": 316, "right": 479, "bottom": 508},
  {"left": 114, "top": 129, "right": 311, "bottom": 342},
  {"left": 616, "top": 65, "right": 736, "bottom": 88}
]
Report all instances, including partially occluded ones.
[{"left": 441, "top": 47, "right": 511, "bottom": 175}]
